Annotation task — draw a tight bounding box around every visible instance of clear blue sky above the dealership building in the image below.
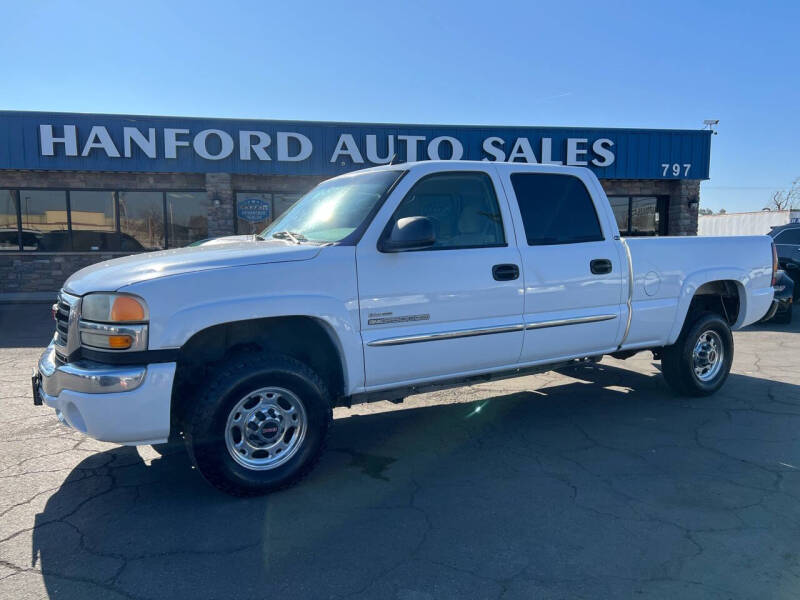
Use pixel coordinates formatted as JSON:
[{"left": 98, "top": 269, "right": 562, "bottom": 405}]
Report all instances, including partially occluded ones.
[{"left": 0, "top": 0, "right": 800, "bottom": 212}]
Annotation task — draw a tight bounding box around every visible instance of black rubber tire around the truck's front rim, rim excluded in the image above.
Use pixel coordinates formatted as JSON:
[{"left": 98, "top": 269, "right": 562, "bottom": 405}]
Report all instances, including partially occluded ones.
[{"left": 183, "top": 353, "right": 332, "bottom": 496}]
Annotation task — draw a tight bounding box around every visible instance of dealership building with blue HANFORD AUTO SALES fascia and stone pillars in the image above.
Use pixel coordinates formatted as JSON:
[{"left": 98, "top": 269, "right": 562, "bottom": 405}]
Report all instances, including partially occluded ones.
[{"left": 0, "top": 111, "right": 711, "bottom": 301}]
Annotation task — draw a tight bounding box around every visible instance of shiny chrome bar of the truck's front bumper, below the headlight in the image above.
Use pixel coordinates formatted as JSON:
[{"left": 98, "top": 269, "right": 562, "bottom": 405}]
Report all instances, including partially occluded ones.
[{"left": 39, "top": 343, "right": 147, "bottom": 396}]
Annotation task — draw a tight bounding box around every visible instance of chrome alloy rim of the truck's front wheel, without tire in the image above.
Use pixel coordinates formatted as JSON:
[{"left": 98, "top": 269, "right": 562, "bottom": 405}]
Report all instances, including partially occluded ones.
[{"left": 225, "top": 387, "right": 308, "bottom": 471}]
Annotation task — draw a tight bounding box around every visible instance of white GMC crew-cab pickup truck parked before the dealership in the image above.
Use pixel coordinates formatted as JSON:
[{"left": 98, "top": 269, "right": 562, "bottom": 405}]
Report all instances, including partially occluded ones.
[{"left": 33, "top": 161, "right": 776, "bottom": 495}]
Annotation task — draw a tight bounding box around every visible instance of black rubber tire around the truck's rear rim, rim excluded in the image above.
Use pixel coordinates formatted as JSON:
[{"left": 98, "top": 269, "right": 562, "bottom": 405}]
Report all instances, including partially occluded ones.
[{"left": 661, "top": 312, "right": 733, "bottom": 396}]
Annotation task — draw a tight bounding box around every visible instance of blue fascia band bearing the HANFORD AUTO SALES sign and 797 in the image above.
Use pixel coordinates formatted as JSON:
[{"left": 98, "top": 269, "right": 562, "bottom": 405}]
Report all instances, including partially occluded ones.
[{"left": 0, "top": 111, "right": 711, "bottom": 179}]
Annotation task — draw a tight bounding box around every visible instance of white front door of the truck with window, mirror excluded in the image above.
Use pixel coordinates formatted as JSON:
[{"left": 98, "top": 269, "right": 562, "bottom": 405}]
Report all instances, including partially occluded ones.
[{"left": 356, "top": 164, "right": 524, "bottom": 389}]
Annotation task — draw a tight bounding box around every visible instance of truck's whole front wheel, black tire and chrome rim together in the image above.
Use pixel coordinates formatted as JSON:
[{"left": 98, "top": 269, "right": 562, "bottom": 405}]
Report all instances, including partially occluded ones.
[{"left": 185, "top": 354, "right": 332, "bottom": 496}]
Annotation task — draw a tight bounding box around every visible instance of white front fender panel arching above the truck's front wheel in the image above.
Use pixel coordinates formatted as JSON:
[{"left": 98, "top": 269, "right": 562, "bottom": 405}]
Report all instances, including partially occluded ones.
[{"left": 125, "top": 248, "right": 364, "bottom": 392}]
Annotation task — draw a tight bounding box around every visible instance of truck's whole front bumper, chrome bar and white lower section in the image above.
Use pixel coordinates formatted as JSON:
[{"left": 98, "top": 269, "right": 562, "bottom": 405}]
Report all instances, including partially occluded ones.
[{"left": 37, "top": 345, "right": 175, "bottom": 446}]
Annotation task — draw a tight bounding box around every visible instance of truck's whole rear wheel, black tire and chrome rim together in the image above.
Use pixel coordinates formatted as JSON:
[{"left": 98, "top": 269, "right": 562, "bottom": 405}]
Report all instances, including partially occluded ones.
[{"left": 661, "top": 313, "right": 733, "bottom": 396}]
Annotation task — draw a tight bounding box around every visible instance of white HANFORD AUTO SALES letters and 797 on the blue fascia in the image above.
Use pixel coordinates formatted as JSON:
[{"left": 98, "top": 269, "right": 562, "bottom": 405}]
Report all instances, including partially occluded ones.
[{"left": 39, "top": 124, "right": 624, "bottom": 169}]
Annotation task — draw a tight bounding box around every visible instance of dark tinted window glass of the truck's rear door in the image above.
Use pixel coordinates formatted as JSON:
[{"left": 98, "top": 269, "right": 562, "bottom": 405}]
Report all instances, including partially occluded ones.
[{"left": 511, "top": 173, "right": 604, "bottom": 246}]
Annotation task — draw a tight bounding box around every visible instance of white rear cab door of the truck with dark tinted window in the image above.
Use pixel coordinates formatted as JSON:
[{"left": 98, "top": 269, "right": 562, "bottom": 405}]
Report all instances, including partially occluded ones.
[{"left": 503, "top": 168, "right": 628, "bottom": 363}]
